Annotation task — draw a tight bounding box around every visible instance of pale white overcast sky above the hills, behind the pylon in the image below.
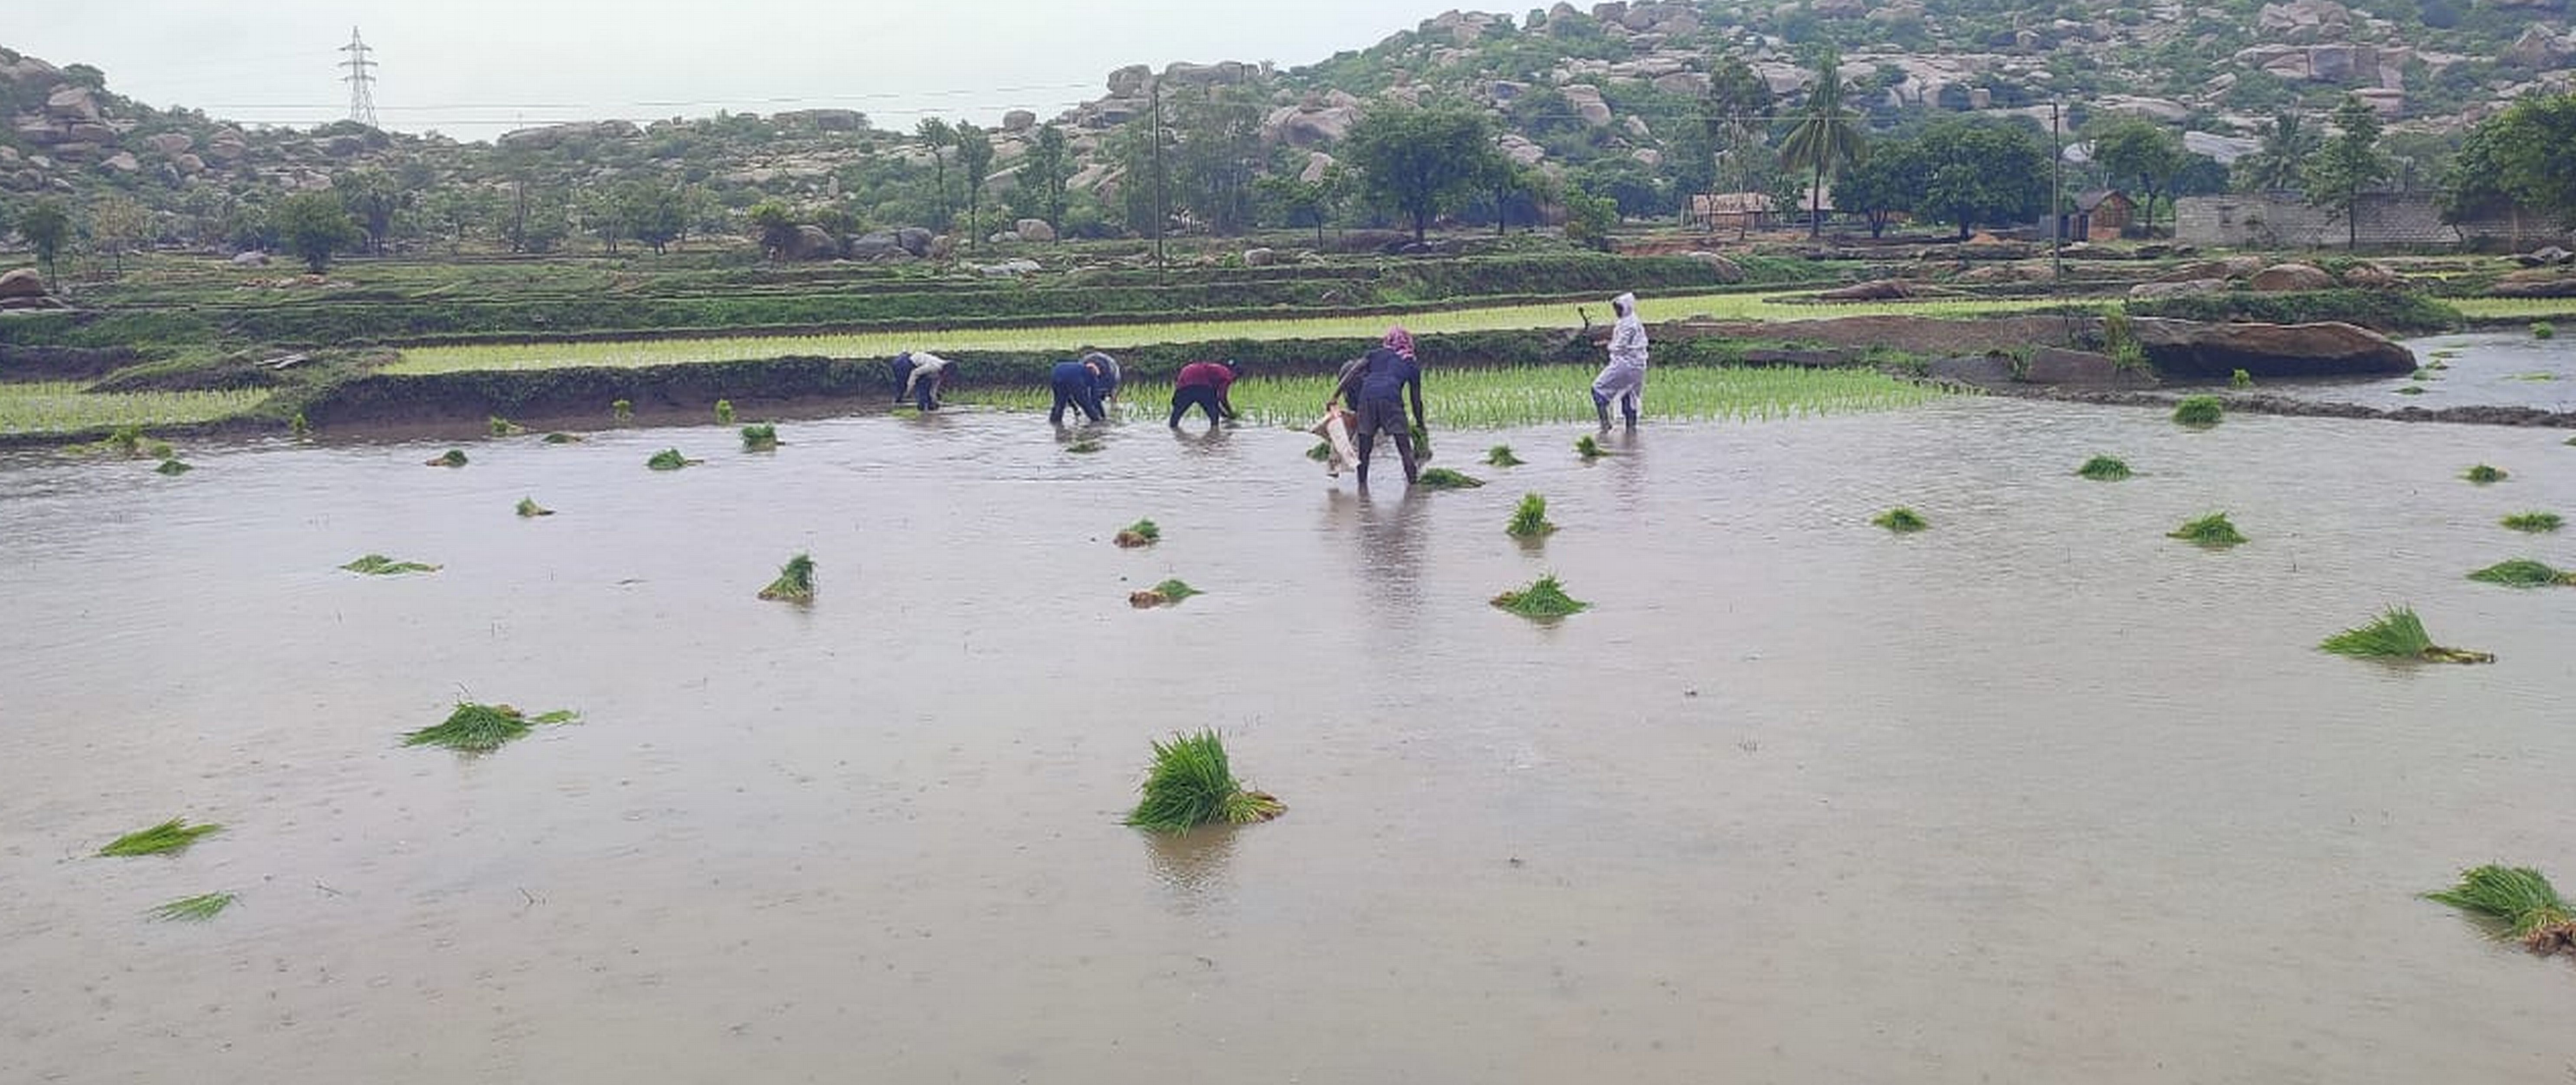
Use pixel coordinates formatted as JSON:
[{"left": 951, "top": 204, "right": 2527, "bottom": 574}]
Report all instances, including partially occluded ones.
[{"left": 15, "top": 0, "right": 1473, "bottom": 139}]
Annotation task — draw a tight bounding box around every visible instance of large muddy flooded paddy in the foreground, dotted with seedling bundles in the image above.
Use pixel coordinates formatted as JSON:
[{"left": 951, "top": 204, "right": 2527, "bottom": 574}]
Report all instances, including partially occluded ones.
[{"left": 0, "top": 399, "right": 2576, "bottom": 1082}]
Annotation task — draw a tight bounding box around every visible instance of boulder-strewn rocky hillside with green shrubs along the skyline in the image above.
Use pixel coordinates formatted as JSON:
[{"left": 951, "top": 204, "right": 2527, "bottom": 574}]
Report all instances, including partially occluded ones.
[{"left": 0, "top": 0, "right": 2576, "bottom": 258}]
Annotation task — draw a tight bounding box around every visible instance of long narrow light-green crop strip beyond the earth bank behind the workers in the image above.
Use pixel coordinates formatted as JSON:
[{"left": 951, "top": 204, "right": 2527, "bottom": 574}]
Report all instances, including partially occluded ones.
[{"left": 387, "top": 294, "right": 2053, "bottom": 374}]
